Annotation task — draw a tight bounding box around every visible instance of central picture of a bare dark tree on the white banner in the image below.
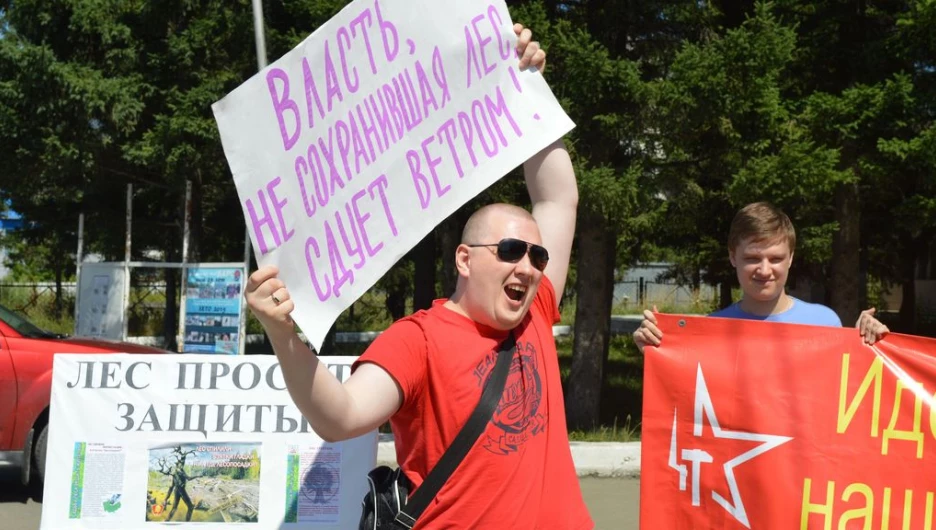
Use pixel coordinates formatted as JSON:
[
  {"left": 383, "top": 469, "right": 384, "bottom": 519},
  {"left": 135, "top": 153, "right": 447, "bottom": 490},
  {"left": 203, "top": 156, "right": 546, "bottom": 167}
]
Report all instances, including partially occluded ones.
[{"left": 146, "top": 443, "right": 261, "bottom": 523}]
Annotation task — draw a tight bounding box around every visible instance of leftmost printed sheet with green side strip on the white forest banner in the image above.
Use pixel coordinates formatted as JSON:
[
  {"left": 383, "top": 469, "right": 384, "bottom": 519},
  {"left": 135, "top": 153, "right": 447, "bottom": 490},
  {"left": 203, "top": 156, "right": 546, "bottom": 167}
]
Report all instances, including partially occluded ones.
[{"left": 68, "top": 442, "right": 125, "bottom": 519}]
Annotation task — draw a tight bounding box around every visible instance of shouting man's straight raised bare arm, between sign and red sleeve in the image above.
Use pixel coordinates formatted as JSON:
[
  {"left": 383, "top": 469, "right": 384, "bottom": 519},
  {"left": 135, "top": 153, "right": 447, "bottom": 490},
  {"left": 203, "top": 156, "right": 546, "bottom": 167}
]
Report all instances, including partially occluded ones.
[{"left": 523, "top": 140, "right": 578, "bottom": 300}]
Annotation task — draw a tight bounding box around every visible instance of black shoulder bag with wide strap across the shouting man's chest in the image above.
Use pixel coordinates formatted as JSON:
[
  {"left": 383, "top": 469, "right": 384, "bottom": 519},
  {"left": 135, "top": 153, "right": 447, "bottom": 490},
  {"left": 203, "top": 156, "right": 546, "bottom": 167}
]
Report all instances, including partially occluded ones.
[{"left": 358, "top": 332, "right": 517, "bottom": 530}]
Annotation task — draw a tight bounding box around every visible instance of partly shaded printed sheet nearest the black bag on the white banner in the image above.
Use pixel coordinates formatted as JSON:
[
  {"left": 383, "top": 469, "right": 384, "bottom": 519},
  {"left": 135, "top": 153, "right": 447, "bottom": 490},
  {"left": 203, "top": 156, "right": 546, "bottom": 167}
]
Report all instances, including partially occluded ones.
[{"left": 283, "top": 443, "right": 341, "bottom": 524}]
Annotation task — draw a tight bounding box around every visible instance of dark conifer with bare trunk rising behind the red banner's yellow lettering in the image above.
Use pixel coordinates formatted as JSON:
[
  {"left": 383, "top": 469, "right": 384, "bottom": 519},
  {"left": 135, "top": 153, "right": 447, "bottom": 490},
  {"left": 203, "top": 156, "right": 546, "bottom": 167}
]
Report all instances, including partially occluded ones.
[{"left": 775, "top": 0, "right": 922, "bottom": 322}]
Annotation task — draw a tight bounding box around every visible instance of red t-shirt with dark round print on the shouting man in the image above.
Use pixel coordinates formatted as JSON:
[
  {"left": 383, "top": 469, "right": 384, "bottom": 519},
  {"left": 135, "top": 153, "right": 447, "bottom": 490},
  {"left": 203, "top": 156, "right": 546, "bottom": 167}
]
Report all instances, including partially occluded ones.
[{"left": 356, "top": 276, "right": 594, "bottom": 530}]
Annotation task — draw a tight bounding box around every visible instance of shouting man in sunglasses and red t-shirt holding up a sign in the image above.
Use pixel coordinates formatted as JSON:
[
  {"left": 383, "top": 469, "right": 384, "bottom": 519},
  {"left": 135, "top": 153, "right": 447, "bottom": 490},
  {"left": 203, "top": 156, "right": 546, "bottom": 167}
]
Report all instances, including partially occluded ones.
[{"left": 246, "top": 24, "right": 594, "bottom": 530}]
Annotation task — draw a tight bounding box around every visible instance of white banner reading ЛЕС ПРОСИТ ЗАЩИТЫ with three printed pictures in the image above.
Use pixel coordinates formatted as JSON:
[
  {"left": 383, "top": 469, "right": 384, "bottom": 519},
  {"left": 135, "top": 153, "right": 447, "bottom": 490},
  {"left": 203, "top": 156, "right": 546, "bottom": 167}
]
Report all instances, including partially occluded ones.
[{"left": 40, "top": 354, "right": 377, "bottom": 530}]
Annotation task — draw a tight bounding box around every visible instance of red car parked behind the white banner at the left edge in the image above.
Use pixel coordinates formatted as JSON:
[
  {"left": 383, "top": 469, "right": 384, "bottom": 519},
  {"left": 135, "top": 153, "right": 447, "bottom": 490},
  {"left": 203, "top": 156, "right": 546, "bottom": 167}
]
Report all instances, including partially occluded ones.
[{"left": 0, "top": 305, "right": 171, "bottom": 484}]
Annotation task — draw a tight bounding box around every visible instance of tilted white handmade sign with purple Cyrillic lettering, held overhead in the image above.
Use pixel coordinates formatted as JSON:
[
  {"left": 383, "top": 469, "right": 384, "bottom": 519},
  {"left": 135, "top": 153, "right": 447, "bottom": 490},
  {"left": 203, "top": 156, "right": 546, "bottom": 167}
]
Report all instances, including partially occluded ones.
[{"left": 213, "top": 0, "right": 573, "bottom": 349}]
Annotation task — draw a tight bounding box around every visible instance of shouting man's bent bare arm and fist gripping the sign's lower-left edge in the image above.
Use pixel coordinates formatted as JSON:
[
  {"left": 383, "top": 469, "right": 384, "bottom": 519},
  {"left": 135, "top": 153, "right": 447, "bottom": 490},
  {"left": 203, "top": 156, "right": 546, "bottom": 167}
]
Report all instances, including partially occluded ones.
[{"left": 244, "top": 266, "right": 403, "bottom": 442}]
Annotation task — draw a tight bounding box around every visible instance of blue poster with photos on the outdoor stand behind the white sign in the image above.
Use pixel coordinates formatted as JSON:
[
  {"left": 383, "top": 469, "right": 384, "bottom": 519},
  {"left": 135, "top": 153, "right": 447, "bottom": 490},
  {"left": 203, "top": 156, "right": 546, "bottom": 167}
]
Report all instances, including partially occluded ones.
[{"left": 182, "top": 263, "right": 247, "bottom": 354}]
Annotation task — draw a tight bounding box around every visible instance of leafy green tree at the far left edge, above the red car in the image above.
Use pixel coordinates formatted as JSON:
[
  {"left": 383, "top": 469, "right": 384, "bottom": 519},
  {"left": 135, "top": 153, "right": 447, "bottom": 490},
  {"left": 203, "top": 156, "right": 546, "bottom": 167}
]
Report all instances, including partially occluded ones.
[{"left": 0, "top": 1, "right": 148, "bottom": 311}]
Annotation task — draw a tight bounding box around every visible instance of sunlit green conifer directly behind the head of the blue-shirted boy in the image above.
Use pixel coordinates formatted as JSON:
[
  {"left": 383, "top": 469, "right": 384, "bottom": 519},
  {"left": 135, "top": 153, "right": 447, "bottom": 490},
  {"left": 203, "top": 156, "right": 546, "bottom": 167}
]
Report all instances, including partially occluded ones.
[{"left": 653, "top": 4, "right": 796, "bottom": 307}]
